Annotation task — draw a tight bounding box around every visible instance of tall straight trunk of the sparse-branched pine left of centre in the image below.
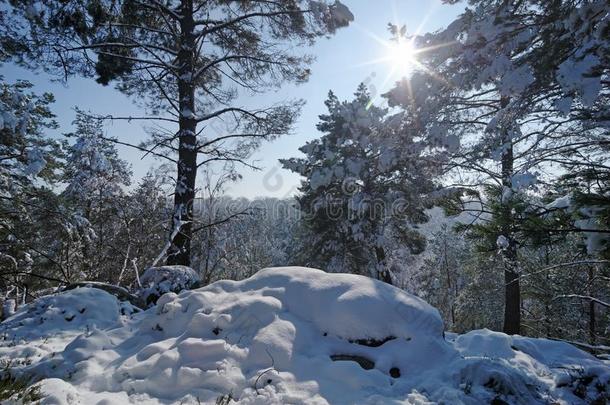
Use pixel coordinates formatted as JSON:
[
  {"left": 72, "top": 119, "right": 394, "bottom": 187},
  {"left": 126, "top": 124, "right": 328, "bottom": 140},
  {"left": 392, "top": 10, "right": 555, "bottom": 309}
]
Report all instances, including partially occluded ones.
[{"left": 167, "top": 0, "right": 197, "bottom": 266}]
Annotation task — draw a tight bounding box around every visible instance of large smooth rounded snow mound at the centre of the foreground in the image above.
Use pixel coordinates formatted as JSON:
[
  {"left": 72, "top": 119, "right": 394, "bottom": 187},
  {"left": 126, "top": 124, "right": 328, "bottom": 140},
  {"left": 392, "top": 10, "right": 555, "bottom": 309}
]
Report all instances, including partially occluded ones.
[{"left": 202, "top": 267, "right": 443, "bottom": 340}]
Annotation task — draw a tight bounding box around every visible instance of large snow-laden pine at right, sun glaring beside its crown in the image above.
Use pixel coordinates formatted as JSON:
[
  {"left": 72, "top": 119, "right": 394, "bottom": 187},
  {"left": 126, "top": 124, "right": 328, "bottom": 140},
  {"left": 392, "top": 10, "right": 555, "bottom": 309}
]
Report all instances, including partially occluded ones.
[{"left": 388, "top": 1, "right": 609, "bottom": 333}]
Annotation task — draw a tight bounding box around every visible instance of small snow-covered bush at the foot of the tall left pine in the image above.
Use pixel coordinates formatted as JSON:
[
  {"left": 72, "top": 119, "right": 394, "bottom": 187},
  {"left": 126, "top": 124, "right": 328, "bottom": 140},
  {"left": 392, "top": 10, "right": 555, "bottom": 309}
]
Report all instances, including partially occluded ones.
[{"left": 138, "top": 265, "right": 200, "bottom": 305}]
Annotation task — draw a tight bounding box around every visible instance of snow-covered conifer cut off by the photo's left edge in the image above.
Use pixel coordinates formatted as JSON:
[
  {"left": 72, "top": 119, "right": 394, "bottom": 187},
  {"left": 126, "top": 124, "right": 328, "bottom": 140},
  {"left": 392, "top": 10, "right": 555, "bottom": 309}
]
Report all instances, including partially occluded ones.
[{"left": 0, "top": 76, "right": 61, "bottom": 302}]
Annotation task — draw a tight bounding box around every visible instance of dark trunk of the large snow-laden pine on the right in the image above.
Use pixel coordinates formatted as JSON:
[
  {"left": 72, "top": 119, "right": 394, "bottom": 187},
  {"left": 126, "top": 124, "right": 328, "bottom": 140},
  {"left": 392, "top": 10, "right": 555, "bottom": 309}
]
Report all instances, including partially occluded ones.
[{"left": 500, "top": 97, "right": 521, "bottom": 335}]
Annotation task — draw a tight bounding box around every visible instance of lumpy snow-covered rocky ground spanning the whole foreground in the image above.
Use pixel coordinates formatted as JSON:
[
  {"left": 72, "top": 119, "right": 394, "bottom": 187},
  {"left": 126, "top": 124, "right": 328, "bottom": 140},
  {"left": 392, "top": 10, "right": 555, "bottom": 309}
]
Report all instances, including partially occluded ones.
[{"left": 0, "top": 267, "right": 610, "bottom": 405}]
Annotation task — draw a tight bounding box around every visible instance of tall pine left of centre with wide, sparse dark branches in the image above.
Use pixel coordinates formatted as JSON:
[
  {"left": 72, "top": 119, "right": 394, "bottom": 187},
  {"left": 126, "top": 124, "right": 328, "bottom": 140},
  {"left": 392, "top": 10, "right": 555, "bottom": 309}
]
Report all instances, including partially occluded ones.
[{"left": 1, "top": 0, "right": 353, "bottom": 265}]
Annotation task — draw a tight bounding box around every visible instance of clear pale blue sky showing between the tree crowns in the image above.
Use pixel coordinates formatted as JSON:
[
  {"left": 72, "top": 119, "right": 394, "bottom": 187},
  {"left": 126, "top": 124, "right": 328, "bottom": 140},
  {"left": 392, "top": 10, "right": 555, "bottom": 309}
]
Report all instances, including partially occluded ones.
[{"left": 0, "top": 0, "right": 463, "bottom": 198}]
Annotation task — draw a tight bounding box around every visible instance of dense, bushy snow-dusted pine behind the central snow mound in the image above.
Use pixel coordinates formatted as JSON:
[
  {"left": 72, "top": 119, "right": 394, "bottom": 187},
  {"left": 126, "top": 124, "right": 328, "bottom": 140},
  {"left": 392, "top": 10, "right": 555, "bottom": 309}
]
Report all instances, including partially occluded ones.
[{"left": 282, "top": 85, "right": 435, "bottom": 282}]
